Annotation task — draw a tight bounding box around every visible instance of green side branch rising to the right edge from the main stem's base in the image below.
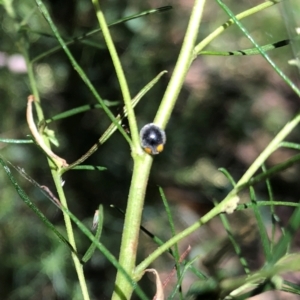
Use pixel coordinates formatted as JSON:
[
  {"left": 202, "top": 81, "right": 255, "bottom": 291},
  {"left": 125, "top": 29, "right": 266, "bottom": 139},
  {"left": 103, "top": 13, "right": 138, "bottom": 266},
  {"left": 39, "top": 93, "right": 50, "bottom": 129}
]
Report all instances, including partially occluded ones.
[{"left": 136, "top": 113, "right": 300, "bottom": 276}]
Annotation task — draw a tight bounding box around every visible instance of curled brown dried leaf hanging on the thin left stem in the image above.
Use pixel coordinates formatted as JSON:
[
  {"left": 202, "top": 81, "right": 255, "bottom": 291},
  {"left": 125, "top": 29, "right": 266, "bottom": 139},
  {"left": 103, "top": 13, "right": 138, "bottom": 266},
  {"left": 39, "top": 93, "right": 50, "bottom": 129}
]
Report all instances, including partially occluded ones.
[{"left": 26, "top": 95, "right": 68, "bottom": 167}]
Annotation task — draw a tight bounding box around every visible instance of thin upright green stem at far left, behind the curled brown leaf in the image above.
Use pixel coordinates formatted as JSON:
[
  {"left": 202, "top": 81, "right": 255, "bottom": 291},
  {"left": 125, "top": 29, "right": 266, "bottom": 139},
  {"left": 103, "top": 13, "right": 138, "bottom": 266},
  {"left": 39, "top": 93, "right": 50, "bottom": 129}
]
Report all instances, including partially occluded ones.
[{"left": 20, "top": 37, "right": 90, "bottom": 300}]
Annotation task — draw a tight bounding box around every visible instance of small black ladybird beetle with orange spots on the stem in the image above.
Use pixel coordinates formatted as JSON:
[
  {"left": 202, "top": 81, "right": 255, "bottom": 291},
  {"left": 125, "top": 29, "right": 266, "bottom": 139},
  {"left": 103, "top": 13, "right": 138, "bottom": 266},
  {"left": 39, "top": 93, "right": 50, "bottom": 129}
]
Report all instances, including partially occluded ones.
[{"left": 140, "top": 123, "right": 166, "bottom": 155}]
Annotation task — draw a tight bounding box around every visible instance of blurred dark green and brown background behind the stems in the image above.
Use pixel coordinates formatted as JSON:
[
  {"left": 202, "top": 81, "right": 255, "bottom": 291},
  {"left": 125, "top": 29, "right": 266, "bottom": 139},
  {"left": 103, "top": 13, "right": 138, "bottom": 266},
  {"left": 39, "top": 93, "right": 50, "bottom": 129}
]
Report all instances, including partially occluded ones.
[{"left": 0, "top": 0, "right": 300, "bottom": 300}]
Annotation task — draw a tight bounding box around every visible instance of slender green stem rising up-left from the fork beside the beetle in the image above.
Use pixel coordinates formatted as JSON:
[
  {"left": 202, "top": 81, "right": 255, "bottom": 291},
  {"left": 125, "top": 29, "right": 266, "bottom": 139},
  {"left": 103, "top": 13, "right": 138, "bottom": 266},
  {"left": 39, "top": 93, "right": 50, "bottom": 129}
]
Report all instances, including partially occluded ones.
[{"left": 92, "top": 0, "right": 143, "bottom": 153}]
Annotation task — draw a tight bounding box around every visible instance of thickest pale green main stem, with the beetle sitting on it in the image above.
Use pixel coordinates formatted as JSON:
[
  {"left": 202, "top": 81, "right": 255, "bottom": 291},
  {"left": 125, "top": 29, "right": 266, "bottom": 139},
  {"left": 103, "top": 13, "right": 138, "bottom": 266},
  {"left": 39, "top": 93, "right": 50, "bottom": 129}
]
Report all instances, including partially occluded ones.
[{"left": 112, "top": 0, "right": 205, "bottom": 300}]
